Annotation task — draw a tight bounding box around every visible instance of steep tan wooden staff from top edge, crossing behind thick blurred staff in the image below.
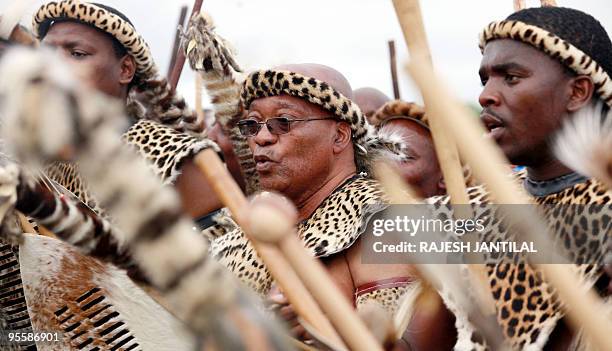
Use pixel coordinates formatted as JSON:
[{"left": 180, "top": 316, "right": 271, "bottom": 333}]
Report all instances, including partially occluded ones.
[{"left": 393, "top": 0, "right": 468, "bottom": 205}]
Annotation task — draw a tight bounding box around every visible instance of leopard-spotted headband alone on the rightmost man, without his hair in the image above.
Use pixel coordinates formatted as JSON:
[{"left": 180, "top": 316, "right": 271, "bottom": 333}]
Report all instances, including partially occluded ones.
[{"left": 479, "top": 20, "right": 612, "bottom": 107}]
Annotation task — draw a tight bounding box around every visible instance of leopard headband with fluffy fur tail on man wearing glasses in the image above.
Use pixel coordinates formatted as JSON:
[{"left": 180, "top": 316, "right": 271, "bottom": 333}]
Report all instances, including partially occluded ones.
[{"left": 240, "top": 70, "right": 405, "bottom": 172}]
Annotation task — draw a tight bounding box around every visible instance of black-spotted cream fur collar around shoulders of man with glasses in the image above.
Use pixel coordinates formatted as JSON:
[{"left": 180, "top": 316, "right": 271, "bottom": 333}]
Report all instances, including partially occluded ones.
[{"left": 211, "top": 177, "right": 383, "bottom": 297}]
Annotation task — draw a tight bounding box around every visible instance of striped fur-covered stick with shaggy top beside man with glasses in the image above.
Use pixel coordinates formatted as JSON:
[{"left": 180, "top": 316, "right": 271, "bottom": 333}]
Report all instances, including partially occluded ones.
[{"left": 182, "top": 13, "right": 259, "bottom": 194}]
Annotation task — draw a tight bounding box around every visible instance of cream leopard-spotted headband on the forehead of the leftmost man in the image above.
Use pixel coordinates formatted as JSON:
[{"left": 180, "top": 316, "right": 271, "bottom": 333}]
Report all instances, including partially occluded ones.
[{"left": 32, "top": 0, "right": 157, "bottom": 80}]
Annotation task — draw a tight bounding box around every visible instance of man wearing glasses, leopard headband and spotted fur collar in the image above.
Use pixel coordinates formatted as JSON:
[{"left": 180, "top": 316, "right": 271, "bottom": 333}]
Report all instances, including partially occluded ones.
[{"left": 211, "top": 64, "right": 452, "bottom": 346}]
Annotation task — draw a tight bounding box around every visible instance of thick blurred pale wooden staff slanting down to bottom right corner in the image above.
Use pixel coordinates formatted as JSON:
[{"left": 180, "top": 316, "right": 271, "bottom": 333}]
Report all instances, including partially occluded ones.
[{"left": 407, "top": 58, "right": 612, "bottom": 350}]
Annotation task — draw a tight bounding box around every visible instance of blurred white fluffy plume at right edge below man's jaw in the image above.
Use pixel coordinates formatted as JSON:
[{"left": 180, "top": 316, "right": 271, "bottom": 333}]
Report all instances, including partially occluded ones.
[{"left": 554, "top": 101, "right": 612, "bottom": 189}]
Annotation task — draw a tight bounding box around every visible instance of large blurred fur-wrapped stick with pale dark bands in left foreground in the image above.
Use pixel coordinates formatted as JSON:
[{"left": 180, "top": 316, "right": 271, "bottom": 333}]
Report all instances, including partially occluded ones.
[{"left": 0, "top": 49, "right": 286, "bottom": 349}]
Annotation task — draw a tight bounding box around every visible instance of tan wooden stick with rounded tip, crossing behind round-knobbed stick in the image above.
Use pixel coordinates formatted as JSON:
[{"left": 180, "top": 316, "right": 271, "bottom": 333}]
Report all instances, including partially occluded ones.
[{"left": 194, "top": 149, "right": 346, "bottom": 349}]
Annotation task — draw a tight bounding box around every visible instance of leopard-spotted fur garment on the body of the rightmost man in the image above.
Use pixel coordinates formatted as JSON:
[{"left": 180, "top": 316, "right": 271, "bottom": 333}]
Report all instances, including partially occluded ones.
[{"left": 436, "top": 173, "right": 612, "bottom": 350}]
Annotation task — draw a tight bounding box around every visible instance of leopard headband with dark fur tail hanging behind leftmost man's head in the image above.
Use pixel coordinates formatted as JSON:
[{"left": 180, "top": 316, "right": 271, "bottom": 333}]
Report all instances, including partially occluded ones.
[{"left": 32, "top": 0, "right": 204, "bottom": 133}]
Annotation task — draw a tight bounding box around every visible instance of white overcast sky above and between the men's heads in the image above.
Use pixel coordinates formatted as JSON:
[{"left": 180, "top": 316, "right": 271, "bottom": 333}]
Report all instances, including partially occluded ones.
[{"left": 0, "top": 0, "right": 612, "bottom": 108}]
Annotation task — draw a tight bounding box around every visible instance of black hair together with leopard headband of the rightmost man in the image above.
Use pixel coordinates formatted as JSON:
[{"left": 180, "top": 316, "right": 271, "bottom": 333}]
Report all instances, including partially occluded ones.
[{"left": 480, "top": 7, "right": 612, "bottom": 106}]
